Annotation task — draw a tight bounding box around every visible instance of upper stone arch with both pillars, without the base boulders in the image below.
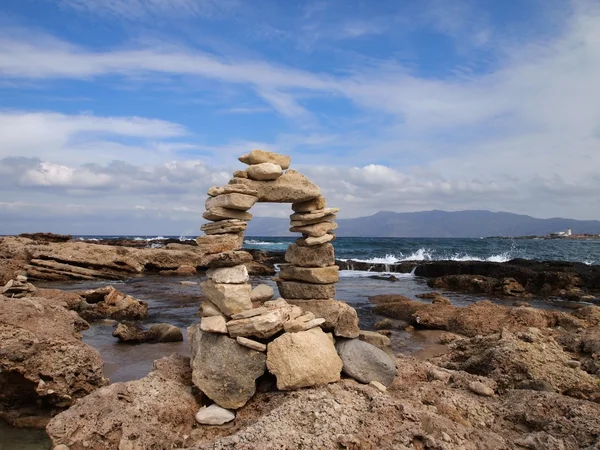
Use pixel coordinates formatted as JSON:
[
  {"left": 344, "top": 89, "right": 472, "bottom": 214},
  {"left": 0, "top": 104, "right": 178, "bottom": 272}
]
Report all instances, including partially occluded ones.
[{"left": 197, "top": 150, "right": 359, "bottom": 337}]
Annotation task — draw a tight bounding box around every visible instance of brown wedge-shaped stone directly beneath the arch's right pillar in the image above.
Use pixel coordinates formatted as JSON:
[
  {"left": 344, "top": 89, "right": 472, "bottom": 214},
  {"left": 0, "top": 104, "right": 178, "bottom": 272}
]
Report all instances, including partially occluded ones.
[{"left": 288, "top": 300, "right": 360, "bottom": 338}]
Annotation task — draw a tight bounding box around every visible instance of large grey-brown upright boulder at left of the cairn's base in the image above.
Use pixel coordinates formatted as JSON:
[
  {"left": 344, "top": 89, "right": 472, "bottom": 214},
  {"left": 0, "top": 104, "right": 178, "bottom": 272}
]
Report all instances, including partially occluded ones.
[{"left": 188, "top": 325, "right": 267, "bottom": 409}]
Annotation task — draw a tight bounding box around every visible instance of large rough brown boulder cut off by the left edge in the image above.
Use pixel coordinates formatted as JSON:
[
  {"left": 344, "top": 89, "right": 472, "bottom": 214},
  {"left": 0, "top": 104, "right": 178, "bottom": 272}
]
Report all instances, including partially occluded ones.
[{"left": 0, "top": 295, "right": 108, "bottom": 409}]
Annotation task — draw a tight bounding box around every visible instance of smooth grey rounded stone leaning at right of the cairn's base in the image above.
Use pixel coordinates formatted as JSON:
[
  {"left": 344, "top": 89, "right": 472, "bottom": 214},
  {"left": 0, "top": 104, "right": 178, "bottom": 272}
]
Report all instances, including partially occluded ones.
[{"left": 335, "top": 339, "right": 396, "bottom": 386}]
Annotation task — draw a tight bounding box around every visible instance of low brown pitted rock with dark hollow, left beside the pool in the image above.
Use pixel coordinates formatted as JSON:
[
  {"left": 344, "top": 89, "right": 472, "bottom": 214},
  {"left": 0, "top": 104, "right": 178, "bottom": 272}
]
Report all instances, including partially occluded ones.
[{"left": 79, "top": 286, "right": 148, "bottom": 320}]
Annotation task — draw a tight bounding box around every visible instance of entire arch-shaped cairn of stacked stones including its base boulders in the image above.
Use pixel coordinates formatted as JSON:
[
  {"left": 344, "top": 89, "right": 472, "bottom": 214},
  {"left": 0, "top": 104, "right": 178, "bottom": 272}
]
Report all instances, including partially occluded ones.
[{"left": 188, "top": 150, "right": 396, "bottom": 425}]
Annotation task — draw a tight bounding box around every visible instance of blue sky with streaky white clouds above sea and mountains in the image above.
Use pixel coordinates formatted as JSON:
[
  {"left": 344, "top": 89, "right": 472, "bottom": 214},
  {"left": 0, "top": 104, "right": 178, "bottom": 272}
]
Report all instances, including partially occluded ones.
[{"left": 0, "top": 0, "right": 600, "bottom": 234}]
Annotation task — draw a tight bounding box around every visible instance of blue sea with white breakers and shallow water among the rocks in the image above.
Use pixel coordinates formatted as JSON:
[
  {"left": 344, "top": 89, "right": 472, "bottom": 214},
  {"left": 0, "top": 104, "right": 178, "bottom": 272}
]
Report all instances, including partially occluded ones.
[{"left": 0, "top": 236, "right": 600, "bottom": 450}]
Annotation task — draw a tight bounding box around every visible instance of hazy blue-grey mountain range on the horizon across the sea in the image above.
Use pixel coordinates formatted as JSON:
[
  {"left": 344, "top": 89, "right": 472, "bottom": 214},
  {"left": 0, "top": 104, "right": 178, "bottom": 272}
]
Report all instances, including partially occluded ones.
[{"left": 246, "top": 210, "right": 600, "bottom": 238}]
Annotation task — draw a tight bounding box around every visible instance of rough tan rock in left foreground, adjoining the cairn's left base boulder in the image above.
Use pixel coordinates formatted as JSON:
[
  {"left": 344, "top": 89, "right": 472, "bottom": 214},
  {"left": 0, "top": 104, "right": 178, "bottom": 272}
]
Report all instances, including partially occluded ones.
[{"left": 46, "top": 354, "right": 200, "bottom": 450}]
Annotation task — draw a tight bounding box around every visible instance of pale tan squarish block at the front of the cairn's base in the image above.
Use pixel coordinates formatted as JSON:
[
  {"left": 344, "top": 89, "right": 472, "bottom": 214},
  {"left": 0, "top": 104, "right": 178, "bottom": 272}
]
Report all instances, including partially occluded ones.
[{"left": 267, "top": 327, "right": 343, "bottom": 390}]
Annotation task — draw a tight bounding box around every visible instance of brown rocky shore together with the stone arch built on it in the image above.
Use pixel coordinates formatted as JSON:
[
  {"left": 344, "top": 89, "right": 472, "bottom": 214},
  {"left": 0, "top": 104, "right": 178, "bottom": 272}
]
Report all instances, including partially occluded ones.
[{"left": 0, "top": 151, "right": 600, "bottom": 450}]
